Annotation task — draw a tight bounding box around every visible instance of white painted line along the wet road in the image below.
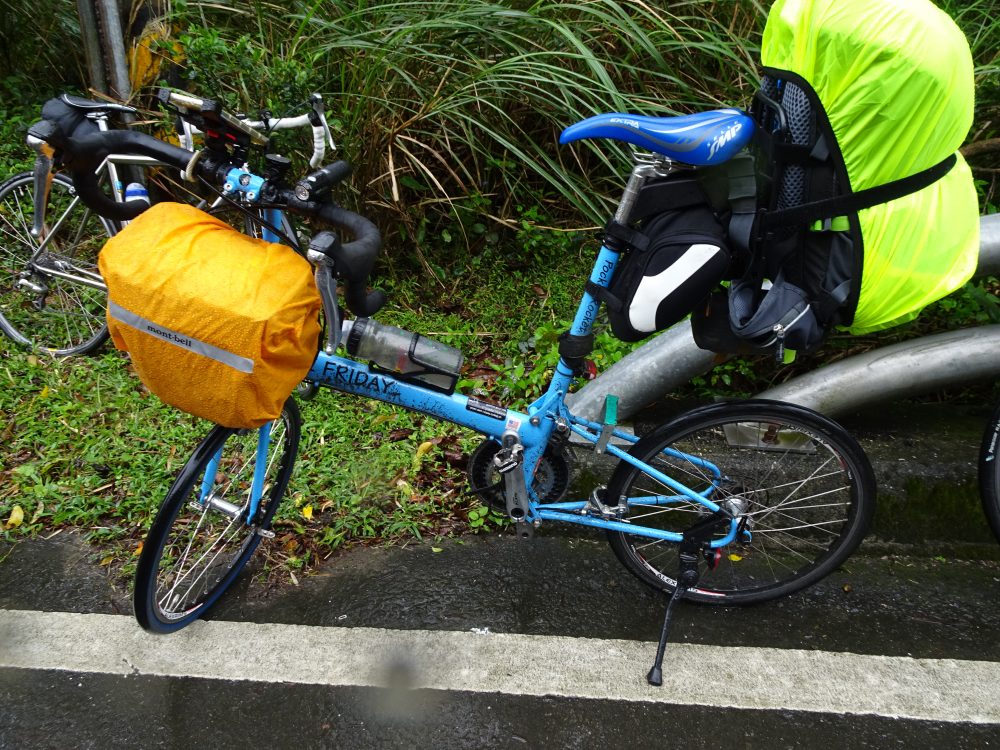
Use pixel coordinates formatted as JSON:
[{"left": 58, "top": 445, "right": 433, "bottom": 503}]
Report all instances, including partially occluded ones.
[{"left": 0, "top": 610, "right": 1000, "bottom": 724}]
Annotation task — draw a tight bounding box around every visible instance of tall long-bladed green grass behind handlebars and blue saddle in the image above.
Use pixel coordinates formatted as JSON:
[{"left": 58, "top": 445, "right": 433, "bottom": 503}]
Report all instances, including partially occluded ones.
[{"left": 164, "top": 0, "right": 764, "bottom": 237}]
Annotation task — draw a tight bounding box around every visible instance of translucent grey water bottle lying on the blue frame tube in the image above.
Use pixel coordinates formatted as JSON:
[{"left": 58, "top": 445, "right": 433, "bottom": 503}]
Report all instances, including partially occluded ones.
[{"left": 344, "top": 318, "right": 462, "bottom": 393}]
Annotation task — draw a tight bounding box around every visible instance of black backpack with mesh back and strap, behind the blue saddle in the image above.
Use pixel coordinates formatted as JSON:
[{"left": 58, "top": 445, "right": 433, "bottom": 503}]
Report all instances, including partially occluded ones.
[{"left": 692, "top": 69, "right": 956, "bottom": 359}]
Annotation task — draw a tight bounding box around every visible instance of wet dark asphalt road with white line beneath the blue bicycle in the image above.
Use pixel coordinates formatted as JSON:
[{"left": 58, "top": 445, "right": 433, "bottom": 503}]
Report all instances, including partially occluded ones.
[{"left": 0, "top": 405, "right": 1000, "bottom": 750}]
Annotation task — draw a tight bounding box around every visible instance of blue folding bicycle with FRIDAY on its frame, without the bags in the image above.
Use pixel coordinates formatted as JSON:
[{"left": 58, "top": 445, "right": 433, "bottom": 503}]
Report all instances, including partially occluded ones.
[{"left": 32, "top": 91, "right": 874, "bottom": 684}]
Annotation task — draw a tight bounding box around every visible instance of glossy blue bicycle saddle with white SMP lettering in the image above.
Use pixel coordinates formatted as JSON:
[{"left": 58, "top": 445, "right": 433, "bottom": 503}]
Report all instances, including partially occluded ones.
[{"left": 559, "top": 109, "right": 754, "bottom": 166}]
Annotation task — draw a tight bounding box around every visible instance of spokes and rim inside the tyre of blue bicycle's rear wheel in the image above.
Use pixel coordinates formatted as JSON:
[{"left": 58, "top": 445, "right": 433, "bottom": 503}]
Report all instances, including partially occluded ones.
[{"left": 624, "top": 418, "right": 856, "bottom": 599}]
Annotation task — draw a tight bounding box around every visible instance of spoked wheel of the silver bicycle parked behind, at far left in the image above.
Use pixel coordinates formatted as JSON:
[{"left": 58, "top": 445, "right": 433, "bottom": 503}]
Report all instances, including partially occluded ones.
[{"left": 0, "top": 172, "right": 119, "bottom": 357}]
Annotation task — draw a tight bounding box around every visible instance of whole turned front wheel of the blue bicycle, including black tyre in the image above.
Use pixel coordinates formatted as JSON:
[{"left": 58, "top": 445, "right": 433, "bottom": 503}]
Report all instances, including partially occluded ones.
[{"left": 133, "top": 399, "right": 302, "bottom": 633}]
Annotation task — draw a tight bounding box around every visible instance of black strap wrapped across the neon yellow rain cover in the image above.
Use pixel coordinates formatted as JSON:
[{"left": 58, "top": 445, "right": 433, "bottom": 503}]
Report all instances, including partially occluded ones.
[{"left": 758, "top": 154, "right": 956, "bottom": 231}]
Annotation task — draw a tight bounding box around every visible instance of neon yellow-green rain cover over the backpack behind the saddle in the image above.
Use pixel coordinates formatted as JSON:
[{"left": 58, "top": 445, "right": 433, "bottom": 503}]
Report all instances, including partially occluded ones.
[{"left": 761, "top": 0, "right": 979, "bottom": 333}]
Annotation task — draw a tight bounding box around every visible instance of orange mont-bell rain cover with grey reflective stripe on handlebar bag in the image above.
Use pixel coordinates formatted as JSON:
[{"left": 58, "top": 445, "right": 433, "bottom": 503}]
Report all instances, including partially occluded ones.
[{"left": 98, "top": 203, "right": 321, "bottom": 427}]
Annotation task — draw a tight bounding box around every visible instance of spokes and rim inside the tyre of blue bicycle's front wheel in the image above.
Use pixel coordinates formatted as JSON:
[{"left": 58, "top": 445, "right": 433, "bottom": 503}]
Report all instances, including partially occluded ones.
[{"left": 152, "top": 417, "right": 292, "bottom": 623}]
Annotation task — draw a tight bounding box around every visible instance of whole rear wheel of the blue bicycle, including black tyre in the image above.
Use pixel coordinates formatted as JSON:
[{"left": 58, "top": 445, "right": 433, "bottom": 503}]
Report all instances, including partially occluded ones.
[{"left": 607, "top": 400, "right": 875, "bottom": 605}]
